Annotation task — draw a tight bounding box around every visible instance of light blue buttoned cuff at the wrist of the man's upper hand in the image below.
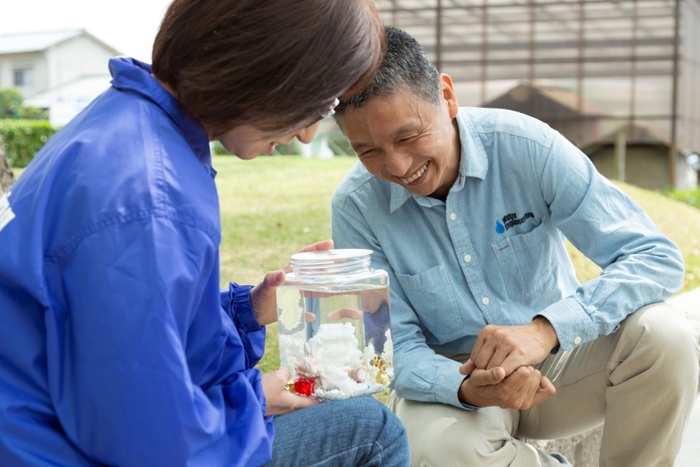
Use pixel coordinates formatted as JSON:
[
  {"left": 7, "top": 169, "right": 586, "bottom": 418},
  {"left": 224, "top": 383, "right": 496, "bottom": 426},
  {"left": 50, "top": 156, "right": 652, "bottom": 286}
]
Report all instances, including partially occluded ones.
[{"left": 536, "top": 298, "right": 598, "bottom": 350}]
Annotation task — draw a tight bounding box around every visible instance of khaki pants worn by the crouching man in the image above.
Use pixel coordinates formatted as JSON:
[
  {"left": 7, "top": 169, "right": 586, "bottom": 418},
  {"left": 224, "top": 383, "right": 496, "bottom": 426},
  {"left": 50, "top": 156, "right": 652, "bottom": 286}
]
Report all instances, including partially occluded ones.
[{"left": 389, "top": 303, "right": 700, "bottom": 467}]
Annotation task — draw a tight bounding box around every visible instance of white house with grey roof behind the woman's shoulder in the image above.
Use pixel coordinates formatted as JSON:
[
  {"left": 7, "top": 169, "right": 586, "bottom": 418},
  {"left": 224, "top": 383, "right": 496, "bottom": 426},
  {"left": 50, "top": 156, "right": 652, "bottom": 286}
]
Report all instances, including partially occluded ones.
[{"left": 0, "top": 29, "right": 119, "bottom": 125}]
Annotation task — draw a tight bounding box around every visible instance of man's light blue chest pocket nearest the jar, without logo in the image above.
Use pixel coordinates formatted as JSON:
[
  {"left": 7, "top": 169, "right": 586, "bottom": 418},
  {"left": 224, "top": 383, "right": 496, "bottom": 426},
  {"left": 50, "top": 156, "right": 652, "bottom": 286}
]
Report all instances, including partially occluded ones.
[{"left": 396, "top": 264, "right": 462, "bottom": 338}]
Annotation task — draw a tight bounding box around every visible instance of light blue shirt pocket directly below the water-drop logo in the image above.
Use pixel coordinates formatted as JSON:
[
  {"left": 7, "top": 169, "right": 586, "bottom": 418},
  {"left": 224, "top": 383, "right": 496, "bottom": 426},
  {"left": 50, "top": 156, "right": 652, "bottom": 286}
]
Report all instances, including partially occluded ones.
[{"left": 491, "top": 217, "right": 553, "bottom": 300}]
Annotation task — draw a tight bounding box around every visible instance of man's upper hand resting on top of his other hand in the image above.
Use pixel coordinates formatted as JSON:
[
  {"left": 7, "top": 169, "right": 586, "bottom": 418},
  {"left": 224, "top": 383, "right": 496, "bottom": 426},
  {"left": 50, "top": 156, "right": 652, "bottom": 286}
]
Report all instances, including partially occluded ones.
[{"left": 465, "top": 316, "right": 559, "bottom": 377}]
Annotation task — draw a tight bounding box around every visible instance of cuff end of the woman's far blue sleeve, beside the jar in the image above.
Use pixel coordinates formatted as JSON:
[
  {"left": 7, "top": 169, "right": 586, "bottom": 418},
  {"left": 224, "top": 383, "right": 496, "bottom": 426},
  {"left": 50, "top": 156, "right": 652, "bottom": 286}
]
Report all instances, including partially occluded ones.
[{"left": 221, "top": 282, "right": 265, "bottom": 368}]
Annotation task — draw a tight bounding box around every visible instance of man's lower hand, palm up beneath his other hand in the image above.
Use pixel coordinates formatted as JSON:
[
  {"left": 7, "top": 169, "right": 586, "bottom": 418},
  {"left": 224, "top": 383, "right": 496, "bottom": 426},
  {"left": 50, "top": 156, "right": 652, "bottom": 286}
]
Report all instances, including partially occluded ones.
[{"left": 458, "top": 366, "right": 557, "bottom": 410}]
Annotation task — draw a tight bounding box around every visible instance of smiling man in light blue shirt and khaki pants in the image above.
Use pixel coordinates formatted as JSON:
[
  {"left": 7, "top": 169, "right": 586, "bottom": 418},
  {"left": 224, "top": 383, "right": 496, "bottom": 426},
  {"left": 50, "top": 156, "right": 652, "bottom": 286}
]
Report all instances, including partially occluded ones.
[{"left": 332, "top": 27, "right": 698, "bottom": 467}]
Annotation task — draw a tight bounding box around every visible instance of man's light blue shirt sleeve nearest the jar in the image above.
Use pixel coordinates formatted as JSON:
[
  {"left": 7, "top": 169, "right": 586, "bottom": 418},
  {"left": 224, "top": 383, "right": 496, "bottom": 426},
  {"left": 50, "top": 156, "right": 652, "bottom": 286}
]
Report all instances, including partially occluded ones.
[{"left": 331, "top": 198, "right": 474, "bottom": 410}]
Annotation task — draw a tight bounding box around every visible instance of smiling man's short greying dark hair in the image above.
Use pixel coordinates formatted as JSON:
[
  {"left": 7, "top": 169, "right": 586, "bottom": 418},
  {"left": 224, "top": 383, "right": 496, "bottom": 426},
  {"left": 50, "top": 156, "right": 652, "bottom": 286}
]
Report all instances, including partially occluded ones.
[{"left": 335, "top": 26, "right": 440, "bottom": 121}]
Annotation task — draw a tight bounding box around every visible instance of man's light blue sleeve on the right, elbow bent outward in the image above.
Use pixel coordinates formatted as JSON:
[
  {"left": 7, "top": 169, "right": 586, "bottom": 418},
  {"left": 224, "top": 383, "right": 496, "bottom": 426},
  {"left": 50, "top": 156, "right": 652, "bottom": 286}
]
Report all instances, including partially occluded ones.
[{"left": 537, "top": 133, "right": 683, "bottom": 350}]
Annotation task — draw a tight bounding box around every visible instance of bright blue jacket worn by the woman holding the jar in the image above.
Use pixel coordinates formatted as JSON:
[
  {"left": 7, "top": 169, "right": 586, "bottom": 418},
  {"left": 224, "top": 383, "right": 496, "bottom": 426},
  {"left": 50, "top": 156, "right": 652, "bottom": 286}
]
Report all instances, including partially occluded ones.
[{"left": 0, "top": 58, "right": 273, "bottom": 466}]
